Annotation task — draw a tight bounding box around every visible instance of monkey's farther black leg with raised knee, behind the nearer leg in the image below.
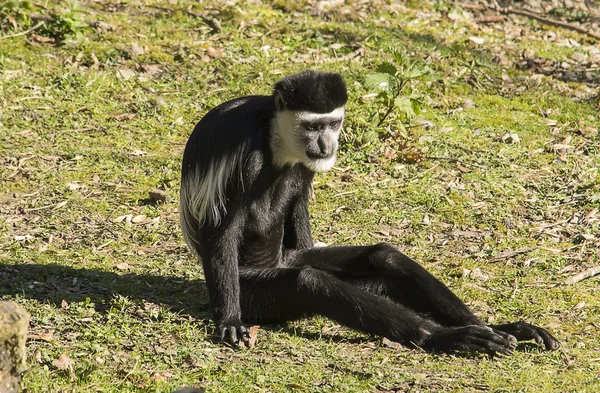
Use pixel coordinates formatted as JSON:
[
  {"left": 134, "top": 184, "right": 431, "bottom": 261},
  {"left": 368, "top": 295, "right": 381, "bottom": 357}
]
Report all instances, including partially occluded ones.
[{"left": 286, "top": 243, "right": 560, "bottom": 349}]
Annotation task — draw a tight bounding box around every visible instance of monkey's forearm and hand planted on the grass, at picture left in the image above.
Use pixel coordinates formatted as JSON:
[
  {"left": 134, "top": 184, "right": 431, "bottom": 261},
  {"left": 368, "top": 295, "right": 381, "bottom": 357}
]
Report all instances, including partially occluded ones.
[{"left": 204, "top": 210, "right": 248, "bottom": 344}]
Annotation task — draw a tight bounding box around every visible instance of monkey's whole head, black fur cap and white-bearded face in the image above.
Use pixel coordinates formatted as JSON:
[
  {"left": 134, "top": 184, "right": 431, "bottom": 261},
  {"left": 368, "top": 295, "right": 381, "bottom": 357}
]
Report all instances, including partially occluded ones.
[{"left": 271, "top": 71, "right": 348, "bottom": 172}]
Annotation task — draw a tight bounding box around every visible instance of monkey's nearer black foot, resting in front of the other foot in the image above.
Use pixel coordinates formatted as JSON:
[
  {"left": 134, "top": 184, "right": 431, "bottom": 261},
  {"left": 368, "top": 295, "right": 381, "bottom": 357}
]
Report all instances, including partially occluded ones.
[{"left": 421, "top": 325, "right": 517, "bottom": 355}]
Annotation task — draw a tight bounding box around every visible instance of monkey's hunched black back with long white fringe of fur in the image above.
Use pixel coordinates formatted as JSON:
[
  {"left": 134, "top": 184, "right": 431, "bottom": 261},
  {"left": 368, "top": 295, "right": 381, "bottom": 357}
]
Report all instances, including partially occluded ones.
[{"left": 180, "top": 96, "right": 275, "bottom": 256}]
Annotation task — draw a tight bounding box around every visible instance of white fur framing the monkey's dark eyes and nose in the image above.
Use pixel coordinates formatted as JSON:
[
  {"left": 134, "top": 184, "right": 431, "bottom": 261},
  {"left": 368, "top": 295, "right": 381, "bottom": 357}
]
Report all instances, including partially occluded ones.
[{"left": 271, "top": 107, "right": 344, "bottom": 172}]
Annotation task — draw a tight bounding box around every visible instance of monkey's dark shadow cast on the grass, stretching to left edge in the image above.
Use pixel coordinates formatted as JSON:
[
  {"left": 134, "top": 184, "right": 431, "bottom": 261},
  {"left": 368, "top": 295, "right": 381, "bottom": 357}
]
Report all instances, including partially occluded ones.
[{"left": 0, "top": 264, "right": 372, "bottom": 343}]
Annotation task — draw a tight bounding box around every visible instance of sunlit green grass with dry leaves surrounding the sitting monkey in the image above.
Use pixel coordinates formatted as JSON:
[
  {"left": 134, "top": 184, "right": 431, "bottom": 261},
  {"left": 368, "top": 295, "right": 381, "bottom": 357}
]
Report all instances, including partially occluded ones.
[{"left": 0, "top": 0, "right": 600, "bottom": 393}]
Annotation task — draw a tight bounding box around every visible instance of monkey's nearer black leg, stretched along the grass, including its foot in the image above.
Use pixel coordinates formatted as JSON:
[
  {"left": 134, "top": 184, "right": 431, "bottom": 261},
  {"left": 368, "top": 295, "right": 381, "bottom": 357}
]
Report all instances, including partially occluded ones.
[{"left": 240, "top": 266, "right": 515, "bottom": 354}]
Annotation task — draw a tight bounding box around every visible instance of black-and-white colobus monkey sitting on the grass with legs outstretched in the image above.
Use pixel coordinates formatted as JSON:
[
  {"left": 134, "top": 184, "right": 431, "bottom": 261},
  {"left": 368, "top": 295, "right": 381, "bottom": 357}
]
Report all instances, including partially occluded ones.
[{"left": 180, "top": 71, "right": 560, "bottom": 354}]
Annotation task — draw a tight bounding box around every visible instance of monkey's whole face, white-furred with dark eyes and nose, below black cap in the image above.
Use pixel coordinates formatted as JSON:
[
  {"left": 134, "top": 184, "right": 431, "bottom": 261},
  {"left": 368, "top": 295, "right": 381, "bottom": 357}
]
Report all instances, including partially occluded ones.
[{"left": 272, "top": 107, "right": 344, "bottom": 172}]
